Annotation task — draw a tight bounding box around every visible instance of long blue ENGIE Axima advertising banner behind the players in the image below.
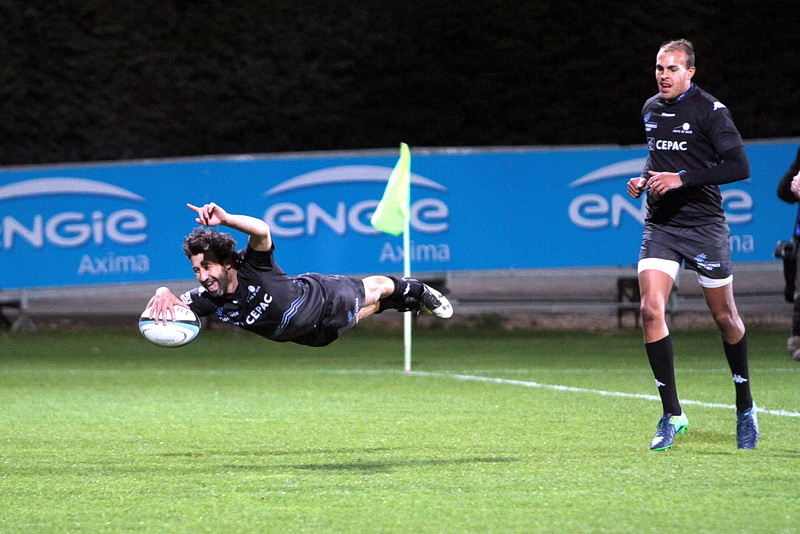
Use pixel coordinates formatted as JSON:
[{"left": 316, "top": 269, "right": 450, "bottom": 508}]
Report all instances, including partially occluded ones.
[{"left": 0, "top": 140, "right": 798, "bottom": 289}]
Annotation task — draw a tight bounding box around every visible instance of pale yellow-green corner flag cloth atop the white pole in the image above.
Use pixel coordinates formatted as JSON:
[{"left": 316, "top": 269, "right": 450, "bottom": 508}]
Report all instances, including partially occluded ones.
[{"left": 370, "top": 143, "right": 411, "bottom": 235}]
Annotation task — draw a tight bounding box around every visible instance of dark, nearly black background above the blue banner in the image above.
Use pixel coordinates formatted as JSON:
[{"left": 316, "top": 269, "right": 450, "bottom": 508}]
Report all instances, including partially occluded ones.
[{"left": 0, "top": 0, "right": 800, "bottom": 165}]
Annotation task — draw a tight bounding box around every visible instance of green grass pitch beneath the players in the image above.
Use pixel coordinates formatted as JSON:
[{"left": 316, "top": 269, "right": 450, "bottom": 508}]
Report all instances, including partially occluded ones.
[{"left": 0, "top": 328, "right": 800, "bottom": 533}]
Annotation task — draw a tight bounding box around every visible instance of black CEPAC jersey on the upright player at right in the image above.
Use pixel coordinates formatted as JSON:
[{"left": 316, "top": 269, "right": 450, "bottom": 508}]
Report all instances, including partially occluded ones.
[{"left": 642, "top": 84, "right": 744, "bottom": 227}]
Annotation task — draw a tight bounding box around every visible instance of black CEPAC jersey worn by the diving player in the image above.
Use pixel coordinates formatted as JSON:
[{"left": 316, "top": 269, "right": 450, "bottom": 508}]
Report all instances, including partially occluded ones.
[{"left": 180, "top": 247, "right": 324, "bottom": 341}]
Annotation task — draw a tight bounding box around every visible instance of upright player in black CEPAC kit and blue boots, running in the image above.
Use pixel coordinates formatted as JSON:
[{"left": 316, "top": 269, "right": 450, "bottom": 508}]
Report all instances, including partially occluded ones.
[{"left": 627, "top": 39, "right": 759, "bottom": 450}]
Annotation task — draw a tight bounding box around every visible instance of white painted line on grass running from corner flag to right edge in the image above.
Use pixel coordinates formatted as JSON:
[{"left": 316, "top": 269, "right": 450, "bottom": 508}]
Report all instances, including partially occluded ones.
[{"left": 330, "top": 370, "right": 800, "bottom": 417}]
